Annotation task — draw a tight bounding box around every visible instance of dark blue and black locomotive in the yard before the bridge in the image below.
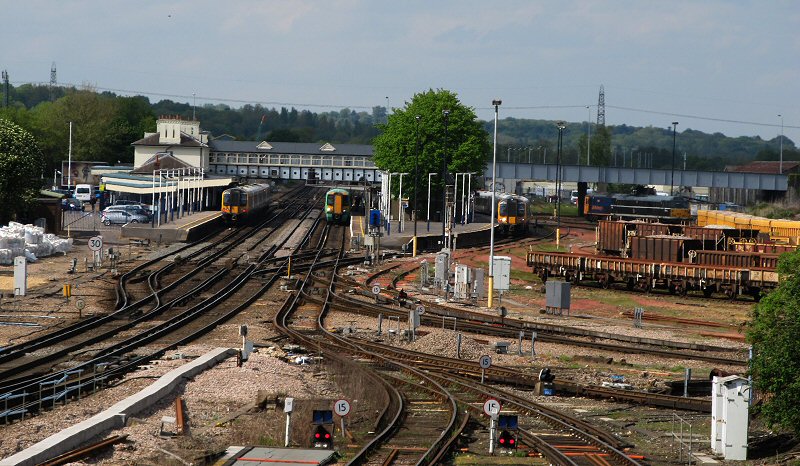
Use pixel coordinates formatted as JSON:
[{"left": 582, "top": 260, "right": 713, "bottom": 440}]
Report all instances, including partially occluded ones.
[{"left": 583, "top": 194, "right": 692, "bottom": 223}]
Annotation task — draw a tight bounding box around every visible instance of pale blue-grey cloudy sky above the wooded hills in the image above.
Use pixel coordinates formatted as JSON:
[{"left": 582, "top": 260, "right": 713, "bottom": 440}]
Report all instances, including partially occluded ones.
[{"left": 0, "top": 0, "right": 800, "bottom": 141}]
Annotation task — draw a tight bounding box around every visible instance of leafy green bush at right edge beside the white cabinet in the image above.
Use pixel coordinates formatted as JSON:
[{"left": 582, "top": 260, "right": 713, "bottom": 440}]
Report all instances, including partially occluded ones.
[{"left": 747, "top": 252, "right": 800, "bottom": 434}]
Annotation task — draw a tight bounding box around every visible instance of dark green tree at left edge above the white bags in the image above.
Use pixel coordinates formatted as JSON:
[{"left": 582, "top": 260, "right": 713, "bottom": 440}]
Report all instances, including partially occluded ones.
[{"left": 0, "top": 119, "right": 44, "bottom": 224}]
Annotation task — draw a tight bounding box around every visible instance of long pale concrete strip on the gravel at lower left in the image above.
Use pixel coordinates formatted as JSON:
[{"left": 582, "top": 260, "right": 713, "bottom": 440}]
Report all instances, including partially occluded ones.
[{"left": 0, "top": 348, "right": 236, "bottom": 466}]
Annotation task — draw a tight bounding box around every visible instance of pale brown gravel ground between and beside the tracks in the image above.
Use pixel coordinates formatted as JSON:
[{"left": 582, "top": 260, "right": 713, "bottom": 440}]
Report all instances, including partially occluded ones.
[{"left": 0, "top": 224, "right": 788, "bottom": 464}]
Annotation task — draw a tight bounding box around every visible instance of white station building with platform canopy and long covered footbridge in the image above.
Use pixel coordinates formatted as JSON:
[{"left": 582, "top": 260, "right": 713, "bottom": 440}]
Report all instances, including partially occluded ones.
[{"left": 97, "top": 116, "right": 382, "bottom": 208}]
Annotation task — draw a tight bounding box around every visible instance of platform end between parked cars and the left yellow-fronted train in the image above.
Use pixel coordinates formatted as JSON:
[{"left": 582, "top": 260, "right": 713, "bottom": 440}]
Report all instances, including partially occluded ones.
[{"left": 121, "top": 210, "right": 222, "bottom": 243}]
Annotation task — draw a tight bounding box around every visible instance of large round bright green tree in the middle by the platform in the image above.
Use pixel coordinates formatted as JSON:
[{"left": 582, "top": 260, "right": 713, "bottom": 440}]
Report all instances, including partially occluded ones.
[{"left": 373, "top": 89, "right": 490, "bottom": 206}]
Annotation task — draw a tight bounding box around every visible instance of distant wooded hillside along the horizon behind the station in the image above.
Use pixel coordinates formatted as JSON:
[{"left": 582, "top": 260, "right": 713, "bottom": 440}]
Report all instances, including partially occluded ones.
[{"left": 0, "top": 84, "right": 800, "bottom": 170}]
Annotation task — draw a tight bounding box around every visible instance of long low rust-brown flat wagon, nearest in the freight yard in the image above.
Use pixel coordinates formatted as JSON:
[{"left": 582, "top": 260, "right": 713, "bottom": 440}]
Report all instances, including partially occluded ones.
[{"left": 527, "top": 251, "right": 778, "bottom": 300}]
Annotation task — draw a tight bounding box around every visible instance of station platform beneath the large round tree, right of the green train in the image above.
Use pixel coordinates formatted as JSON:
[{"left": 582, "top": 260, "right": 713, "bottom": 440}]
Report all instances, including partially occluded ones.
[{"left": 351, "top": 215, "right": 490, "bottom": 252}]
